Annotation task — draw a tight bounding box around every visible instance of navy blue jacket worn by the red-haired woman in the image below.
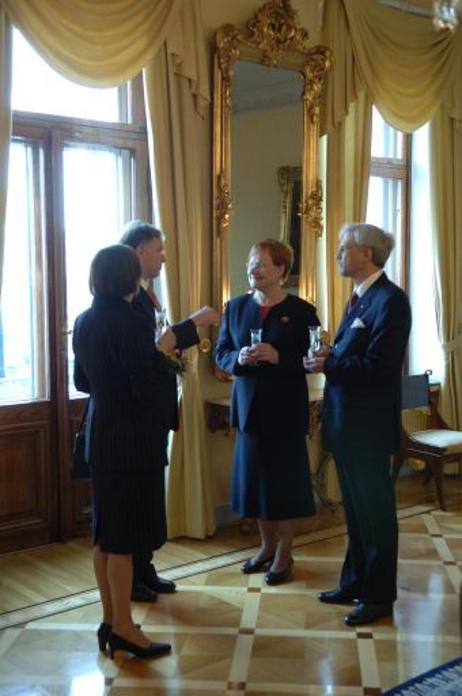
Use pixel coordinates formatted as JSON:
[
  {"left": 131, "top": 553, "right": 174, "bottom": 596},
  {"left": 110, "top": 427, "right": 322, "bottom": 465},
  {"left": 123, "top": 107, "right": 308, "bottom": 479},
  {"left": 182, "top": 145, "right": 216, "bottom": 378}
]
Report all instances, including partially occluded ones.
[{"left": 215, "top": 293, "right": 319, "bottom": 434}]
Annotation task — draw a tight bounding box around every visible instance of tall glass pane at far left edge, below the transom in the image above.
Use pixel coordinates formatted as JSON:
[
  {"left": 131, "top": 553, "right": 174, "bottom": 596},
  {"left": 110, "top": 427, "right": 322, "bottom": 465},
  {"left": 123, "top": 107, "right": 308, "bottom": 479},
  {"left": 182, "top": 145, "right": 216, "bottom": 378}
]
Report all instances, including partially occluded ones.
[{"left": 0, "top": 142, "right": 48, "bottom": 404}]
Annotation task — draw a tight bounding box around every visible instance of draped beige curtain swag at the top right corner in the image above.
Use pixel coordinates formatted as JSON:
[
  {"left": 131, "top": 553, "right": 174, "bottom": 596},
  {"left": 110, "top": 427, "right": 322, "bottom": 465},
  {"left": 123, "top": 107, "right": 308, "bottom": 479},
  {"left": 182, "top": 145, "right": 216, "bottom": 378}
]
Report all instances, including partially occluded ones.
[{"left": 342, "top": 0, "right": 462, "bottom": 132}]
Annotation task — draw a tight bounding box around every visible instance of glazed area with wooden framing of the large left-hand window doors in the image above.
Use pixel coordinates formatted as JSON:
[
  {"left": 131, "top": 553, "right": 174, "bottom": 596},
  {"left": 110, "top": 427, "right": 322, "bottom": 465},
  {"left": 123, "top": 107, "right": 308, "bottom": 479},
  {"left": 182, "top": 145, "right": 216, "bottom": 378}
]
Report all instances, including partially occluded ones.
[{"left": 0, "top": 30, "right": 150, "bottom": 404}]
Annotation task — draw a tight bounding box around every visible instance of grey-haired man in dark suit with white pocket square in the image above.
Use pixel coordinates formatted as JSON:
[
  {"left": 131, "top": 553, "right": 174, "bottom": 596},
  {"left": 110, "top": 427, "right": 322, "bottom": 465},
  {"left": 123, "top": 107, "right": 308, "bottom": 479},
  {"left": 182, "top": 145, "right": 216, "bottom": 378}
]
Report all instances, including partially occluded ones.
[{"left": 305, "top": 223, "right": 411, "bottom": 626}]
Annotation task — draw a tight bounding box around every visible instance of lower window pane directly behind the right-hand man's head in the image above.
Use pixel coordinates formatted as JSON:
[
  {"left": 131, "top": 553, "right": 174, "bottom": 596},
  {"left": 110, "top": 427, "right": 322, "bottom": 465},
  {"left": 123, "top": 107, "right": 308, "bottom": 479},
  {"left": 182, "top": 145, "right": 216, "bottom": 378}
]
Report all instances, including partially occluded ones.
[{"left": 366, "top": 176, "right": 403, "bottom": 285}]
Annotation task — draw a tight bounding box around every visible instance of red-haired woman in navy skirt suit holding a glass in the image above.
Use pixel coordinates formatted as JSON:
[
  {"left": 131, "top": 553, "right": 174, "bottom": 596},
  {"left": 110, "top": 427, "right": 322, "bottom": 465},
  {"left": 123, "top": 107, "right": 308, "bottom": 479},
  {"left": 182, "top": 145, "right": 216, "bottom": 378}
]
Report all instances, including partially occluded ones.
[{"left": 216, "top": 239, "right": 319, "bottom": 585}]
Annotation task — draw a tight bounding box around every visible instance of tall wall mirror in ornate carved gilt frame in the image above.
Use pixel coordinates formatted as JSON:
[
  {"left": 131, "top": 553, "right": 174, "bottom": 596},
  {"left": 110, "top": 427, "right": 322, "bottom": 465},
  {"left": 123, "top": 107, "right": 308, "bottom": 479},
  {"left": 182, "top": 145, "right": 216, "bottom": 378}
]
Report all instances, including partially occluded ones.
[{"left": 213, "top": 0, "right": 331, "bottom": 340}]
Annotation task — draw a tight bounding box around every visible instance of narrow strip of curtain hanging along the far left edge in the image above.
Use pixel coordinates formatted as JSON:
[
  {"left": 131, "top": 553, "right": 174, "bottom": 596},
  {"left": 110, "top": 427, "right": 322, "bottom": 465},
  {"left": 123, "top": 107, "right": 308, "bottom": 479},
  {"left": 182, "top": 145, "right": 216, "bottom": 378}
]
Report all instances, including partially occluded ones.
[{"left": 0, "top": 7, "right": 11, "bottom": 298}]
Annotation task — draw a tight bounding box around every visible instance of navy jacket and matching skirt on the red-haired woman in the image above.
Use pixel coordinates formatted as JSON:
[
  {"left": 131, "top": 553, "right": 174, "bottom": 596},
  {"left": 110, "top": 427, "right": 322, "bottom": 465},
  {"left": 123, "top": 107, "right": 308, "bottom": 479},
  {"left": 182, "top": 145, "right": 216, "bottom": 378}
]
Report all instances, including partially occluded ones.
[{"left": 215, "top": 294, "right": 319, "bottom": 520}]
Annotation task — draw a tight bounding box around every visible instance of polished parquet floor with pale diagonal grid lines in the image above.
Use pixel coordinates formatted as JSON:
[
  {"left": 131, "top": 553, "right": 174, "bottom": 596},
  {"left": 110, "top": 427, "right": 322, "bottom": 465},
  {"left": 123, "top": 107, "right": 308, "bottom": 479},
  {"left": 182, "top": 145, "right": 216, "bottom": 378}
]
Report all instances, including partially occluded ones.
[{"left": 0, "top": 480, "right": 462, "bottom": 696}]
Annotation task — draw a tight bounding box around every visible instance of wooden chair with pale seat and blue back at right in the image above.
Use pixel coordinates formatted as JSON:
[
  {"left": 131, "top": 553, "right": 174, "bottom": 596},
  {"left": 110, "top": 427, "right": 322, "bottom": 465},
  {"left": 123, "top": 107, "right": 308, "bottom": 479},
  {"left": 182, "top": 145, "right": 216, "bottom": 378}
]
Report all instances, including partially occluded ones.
[{"left": 392, "top": 370, "right": 462, "bottom": 510}]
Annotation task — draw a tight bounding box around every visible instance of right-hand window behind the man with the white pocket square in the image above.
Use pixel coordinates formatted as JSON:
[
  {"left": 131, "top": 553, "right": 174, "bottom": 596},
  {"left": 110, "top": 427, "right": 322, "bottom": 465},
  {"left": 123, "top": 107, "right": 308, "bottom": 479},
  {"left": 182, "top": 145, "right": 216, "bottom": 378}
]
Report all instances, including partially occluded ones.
[{"left": 366, "top": 109, "right": 444, "bottom": 381}]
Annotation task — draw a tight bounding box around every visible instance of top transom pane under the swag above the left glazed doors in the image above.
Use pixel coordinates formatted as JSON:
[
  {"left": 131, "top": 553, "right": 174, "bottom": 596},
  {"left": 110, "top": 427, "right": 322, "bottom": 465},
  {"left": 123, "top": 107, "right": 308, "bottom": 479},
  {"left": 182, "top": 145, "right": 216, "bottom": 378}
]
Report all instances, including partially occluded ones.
[{"left": 12, "top": 29, "right": 122, "bottom": 122}]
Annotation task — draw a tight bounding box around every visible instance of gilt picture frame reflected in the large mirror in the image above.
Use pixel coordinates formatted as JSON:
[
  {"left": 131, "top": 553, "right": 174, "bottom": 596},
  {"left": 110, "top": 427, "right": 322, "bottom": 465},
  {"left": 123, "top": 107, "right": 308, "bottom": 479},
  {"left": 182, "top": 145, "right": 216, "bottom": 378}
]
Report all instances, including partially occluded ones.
[{"left": 278, "top": 166, "right": 302, "bottom": 288}]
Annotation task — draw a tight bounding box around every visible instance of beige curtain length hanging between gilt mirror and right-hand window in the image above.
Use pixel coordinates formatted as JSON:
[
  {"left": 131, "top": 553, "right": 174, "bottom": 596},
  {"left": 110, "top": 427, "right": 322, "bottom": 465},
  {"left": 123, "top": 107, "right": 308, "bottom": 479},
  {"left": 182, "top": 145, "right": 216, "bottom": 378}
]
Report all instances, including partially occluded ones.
[{"left": 321, "top": 2, "right": 372, "bottom": 339}]
